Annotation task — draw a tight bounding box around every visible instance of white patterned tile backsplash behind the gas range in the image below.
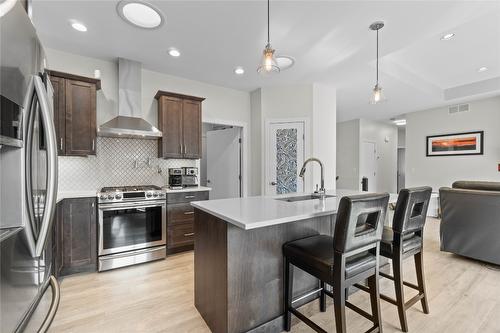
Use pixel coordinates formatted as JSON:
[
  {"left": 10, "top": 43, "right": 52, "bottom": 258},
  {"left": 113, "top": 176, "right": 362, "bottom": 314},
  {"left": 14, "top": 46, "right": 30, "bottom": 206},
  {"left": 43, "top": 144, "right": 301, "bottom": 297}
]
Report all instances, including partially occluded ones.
[{"left": 59, "top": 137, "right": 197, "bottom": 191}]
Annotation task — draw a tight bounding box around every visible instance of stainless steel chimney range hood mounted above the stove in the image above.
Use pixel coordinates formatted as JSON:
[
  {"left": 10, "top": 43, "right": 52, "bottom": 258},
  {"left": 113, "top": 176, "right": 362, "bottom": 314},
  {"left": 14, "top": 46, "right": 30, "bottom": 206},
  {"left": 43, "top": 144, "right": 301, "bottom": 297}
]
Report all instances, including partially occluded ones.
[{"left": 97, "top": 58, "right": 162, "bottom": 139}]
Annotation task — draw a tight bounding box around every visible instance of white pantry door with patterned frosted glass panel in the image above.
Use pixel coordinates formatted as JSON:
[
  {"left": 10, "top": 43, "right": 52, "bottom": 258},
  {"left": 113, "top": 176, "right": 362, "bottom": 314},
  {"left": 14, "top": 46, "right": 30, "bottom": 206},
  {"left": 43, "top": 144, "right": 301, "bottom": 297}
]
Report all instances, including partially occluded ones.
[{"left": 265, "top": 122, "right": 305, "bottom": 195}]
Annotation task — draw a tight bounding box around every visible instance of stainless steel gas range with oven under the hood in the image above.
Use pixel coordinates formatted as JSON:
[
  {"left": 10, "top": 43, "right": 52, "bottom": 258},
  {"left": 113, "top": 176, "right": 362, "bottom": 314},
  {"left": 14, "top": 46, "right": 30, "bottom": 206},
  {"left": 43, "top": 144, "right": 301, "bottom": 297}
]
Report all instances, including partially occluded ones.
[{"left": 97, "top": 185, "right": 167, "bottom": 271}]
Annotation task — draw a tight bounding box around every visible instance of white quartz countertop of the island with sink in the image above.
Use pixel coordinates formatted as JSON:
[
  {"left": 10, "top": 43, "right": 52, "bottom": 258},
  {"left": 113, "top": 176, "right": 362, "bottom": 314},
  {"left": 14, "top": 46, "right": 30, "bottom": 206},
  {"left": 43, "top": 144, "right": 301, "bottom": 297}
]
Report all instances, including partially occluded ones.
[{"left": 191, "top": 189, "right": 397, "bottom": 230}]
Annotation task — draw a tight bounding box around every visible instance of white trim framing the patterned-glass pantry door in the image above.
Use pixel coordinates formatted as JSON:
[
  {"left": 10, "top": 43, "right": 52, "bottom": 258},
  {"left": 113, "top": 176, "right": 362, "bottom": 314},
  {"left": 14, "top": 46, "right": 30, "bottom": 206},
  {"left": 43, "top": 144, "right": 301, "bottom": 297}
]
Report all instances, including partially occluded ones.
[{"left": 261, "top": 117, "right": 312, "bottom": 194}]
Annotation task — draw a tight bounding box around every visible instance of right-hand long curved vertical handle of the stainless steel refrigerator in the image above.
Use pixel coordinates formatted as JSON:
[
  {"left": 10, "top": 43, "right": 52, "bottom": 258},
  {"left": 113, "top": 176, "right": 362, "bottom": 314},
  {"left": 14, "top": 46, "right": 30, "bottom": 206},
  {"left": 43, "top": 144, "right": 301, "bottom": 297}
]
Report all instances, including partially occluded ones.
[{"left": 33, "top": 75, "right": 57, "bottom": 257}]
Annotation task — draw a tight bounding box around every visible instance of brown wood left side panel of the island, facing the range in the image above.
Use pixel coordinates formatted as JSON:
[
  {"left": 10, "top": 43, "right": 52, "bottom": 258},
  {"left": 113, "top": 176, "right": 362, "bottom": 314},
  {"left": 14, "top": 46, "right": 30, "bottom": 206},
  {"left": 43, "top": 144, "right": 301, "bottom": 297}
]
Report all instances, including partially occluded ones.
[{"left": 194, "top": 208, "right": 227, "bottom": 333}]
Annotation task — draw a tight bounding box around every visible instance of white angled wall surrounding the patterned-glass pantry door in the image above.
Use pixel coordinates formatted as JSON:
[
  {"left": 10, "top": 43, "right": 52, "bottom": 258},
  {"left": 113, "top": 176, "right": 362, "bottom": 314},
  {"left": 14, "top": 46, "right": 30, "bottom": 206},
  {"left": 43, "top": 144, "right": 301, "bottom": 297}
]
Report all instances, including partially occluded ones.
[{"left": 251, "top": 84, "right": 336, "bottom": 195}]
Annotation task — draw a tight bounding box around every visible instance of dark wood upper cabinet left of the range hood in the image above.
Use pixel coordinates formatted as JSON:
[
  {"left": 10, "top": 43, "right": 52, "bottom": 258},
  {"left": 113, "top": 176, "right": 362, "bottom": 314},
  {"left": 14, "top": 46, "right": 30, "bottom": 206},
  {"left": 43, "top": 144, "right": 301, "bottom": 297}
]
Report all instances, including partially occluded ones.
[{"left": 49, "top": 71, "right": 101, "bottom": 156}]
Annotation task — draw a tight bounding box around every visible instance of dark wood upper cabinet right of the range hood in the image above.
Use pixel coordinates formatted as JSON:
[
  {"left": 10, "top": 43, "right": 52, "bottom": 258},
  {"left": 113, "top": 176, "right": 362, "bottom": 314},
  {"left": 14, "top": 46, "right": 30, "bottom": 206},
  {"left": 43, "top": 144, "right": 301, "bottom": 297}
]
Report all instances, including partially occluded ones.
[{"left": 155, "top": 91, "right": 204, "bottom": 159}]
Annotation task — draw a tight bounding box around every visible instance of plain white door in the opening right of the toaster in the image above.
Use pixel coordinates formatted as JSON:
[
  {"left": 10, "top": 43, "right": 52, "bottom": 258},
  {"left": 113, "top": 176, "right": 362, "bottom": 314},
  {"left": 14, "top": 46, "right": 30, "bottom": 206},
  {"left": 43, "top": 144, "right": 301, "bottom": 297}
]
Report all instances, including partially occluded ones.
[{"left": 207, "top": 127, "right": 241, "bottom": 199}]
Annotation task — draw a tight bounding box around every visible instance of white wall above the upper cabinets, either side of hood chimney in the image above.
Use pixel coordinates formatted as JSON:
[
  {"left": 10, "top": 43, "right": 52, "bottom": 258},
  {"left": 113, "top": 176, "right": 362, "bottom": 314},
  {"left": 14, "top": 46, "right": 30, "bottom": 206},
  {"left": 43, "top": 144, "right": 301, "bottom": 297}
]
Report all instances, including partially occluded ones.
[{"left": 46, "top": 49, "right": 250, "bottom": 126}]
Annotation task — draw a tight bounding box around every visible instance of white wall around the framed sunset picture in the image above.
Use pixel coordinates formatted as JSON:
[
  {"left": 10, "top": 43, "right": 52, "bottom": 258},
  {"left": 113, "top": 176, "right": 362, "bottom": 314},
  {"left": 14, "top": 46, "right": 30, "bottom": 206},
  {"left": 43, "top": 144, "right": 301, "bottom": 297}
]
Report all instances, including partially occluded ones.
[{"left": 406, "top": 97, "right": 500, "bottom": 191}]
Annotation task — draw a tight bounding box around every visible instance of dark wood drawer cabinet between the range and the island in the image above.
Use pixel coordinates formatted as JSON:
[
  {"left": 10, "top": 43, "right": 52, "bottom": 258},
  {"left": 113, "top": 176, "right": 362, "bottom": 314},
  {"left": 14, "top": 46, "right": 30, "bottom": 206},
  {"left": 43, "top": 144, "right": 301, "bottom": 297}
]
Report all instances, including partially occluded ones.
[{"left": 167, "top": 191, "right": 208, "bottom": 254}]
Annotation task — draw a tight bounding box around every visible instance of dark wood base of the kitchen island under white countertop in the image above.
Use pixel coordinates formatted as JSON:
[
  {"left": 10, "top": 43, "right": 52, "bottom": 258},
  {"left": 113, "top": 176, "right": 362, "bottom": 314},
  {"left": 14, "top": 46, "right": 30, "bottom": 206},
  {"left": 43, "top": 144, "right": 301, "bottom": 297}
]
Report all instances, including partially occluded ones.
[{"left": 194, "top": 208, "right": 335, "bottom": 333}]
